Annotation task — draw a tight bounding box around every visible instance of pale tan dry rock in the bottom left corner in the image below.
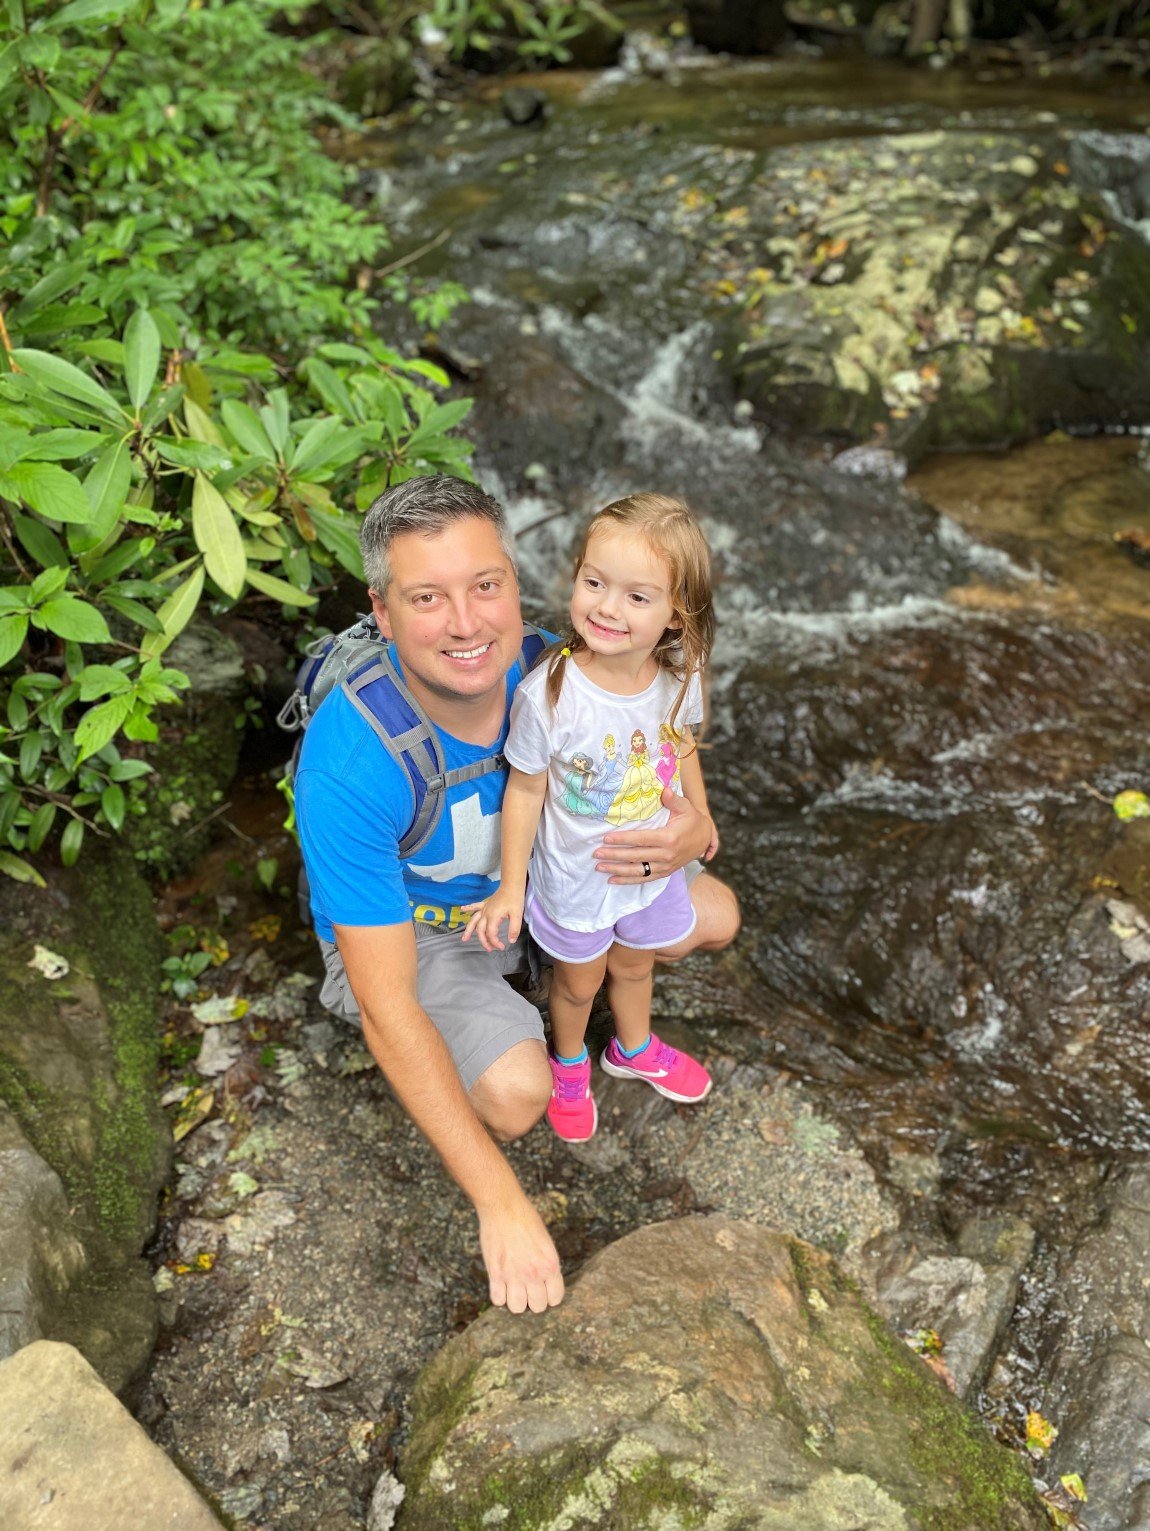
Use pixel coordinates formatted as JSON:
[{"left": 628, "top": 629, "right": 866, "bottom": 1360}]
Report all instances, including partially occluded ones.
[{"left": 0, "top": 1340, "right": 222, "bottom": 1531}]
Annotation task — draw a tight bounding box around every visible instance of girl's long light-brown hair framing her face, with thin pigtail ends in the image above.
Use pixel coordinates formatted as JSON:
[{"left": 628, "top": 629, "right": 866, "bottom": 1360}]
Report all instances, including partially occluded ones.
[{"left": 545, "top": 483, "right": 715, "bottom": 732}]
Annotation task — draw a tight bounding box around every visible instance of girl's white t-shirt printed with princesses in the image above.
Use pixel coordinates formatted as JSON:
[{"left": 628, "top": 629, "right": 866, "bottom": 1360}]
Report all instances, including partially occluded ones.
[{"left": 504, "top": 660, "right": 703, "bottom": 931}]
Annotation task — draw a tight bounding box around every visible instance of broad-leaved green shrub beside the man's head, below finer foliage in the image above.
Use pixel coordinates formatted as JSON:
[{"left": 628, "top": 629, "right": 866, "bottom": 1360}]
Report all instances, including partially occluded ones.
[{"left": 0, "top": 309, "right": 470, "bottom": 863}]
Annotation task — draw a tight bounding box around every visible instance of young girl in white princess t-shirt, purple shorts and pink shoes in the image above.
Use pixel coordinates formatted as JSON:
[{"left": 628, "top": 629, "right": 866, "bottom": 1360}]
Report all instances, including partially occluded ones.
[{"left": 464, "top": 495, "right": 718, "bottom": 1142}]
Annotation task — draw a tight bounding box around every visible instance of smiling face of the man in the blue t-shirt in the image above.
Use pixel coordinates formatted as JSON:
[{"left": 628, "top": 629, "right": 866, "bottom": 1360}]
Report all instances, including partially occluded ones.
[{"left": 372, "top": 516, "right": 524, "bottom": 715}]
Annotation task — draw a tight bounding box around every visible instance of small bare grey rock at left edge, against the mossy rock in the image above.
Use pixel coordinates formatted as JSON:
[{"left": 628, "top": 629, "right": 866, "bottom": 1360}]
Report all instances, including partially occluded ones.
[{"left": 0, "top": 1105, "right": 86, "bottom": 1360}]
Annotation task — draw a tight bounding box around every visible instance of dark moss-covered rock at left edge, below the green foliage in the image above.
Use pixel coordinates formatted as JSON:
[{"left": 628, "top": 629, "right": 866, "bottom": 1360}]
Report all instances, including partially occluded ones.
[{"left": 0, "top": 844, "right": 172, "bottom": 1389}]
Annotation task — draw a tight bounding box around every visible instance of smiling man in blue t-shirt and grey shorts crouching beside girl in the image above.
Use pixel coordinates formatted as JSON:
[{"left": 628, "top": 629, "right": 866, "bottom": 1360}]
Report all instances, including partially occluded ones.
[{"left": 296, "top": 475, "right": 738, "bottom": 1312}]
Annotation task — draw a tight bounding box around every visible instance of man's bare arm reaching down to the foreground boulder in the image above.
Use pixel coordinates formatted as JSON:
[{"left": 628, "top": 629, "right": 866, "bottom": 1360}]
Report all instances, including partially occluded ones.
[{"left": 335, "top": 923, "right": 564, "bottom": 1314}]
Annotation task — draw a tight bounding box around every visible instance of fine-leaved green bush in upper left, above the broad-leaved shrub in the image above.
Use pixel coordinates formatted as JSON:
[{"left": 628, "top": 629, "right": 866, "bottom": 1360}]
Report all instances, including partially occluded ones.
[{"left": 0, "top": 0, "right": 386, "bottom": 347}]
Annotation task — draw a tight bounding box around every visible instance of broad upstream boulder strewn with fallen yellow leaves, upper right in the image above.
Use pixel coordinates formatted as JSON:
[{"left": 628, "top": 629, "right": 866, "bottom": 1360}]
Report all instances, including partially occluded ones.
[{"left": 375, "top": 71, "right": 1150, "bottom": 455}]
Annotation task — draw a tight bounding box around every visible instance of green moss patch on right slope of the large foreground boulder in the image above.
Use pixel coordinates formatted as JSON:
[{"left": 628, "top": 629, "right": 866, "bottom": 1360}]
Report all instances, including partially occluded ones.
[{"left": 859, "top": 1311, "right": 1044, "bottom": 1531}]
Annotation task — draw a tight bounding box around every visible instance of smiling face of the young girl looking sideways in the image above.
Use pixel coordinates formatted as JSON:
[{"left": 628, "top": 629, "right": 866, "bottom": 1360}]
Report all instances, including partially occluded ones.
[{"left": 571, "top": 525, "right": 675, "bottom": 658}]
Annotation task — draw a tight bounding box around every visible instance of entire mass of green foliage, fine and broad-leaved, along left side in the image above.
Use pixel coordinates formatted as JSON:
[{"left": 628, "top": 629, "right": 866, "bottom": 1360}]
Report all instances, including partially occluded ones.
[{"left": 0, "top": 0, "right": 470, "bottom": 880}]
